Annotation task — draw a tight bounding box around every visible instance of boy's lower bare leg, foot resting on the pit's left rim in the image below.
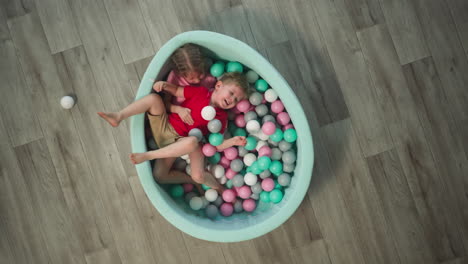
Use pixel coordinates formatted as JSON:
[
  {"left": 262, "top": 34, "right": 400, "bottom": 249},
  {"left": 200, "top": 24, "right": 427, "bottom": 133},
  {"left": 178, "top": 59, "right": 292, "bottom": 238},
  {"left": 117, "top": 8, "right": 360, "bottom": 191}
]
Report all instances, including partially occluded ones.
[{"left": 130, "top": 137, "right": 198, "bottom": 164}]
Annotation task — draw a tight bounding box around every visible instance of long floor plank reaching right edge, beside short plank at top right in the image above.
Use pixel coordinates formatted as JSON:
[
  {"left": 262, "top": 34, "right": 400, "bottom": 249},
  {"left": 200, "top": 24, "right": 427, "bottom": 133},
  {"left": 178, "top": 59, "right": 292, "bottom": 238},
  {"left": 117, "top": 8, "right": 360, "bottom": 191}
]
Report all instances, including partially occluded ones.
[{"left": 415, "top": 0, "right": 468, "bottom": 121}]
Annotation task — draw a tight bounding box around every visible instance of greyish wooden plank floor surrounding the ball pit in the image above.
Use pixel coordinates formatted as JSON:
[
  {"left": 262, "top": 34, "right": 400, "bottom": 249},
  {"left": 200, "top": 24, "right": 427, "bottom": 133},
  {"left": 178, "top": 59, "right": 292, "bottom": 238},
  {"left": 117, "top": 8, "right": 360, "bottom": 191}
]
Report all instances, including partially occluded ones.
[{"left": 0, "top": 0, "right": 468, "bottom": 264}]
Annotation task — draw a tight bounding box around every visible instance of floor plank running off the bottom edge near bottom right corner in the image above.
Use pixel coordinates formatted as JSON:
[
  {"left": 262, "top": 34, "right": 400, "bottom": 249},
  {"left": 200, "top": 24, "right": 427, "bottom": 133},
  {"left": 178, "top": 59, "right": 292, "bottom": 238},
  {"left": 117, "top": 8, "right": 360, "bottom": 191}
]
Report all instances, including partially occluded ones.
[{"left": 367, "top": 150, "right": 438, "bottom": 264}]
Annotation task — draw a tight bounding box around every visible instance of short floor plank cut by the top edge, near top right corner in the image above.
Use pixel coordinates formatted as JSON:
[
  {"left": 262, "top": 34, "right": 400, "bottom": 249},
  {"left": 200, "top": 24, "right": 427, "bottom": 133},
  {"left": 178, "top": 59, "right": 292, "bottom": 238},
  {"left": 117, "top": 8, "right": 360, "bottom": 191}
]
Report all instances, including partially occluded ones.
[{"left": 380, "top": 0, "right": 430, "bottom": 64}]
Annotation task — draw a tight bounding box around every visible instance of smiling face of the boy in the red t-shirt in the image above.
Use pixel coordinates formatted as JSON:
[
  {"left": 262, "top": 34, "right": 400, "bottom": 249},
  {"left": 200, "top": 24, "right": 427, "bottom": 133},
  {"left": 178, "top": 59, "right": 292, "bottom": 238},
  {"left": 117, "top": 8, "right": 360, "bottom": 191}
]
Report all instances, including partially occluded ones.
[{"left": 212, "top": 81, "right": 245, "bottom": 109}]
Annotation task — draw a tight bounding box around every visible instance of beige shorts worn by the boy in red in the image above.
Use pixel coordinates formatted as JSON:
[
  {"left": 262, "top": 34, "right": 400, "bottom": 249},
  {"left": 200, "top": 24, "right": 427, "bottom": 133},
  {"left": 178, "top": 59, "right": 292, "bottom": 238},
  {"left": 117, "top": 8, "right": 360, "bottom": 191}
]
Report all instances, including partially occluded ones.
[{"left": 147, "top": 113, "right": 181, "bottom": 148}]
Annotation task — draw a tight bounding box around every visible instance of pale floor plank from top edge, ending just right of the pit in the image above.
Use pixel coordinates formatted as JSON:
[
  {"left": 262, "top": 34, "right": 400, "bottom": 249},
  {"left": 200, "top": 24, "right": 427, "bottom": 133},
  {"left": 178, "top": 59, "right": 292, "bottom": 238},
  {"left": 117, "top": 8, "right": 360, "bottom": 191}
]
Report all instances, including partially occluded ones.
[{"left": 276, "top": 0, "right": 349, "bottom": 125}]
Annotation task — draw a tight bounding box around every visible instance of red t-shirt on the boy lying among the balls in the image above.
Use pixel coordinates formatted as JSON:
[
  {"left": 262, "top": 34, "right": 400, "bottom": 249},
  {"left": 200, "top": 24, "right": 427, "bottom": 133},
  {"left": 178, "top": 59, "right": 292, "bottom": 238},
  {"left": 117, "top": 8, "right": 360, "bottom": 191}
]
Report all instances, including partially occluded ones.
[{"left": 169, "top": 86, "right": 227, "bottom": 137}]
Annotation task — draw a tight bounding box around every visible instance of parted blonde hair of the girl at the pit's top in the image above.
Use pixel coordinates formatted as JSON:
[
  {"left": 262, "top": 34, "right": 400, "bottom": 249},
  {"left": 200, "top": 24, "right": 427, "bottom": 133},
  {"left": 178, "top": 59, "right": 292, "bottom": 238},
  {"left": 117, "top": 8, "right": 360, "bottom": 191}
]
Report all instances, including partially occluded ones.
[{"left": 171, "top": 43, "right": 207, "bottom": 77}]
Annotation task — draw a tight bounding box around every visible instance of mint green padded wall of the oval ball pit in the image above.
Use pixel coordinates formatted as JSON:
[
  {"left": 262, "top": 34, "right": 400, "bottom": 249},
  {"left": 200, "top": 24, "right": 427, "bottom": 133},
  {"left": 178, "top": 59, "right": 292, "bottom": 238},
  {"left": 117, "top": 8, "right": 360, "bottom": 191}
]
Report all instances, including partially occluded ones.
[{"left": 130, "top": 31, "right": 314, "bottom": 242}]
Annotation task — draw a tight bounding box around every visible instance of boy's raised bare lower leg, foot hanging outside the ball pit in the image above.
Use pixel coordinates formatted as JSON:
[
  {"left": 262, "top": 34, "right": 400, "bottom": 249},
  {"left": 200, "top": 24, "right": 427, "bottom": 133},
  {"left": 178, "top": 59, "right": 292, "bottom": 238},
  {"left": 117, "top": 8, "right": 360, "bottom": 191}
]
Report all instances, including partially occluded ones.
[{"left": 98, "top": 93, "right": 166, "bottom": 127}]
